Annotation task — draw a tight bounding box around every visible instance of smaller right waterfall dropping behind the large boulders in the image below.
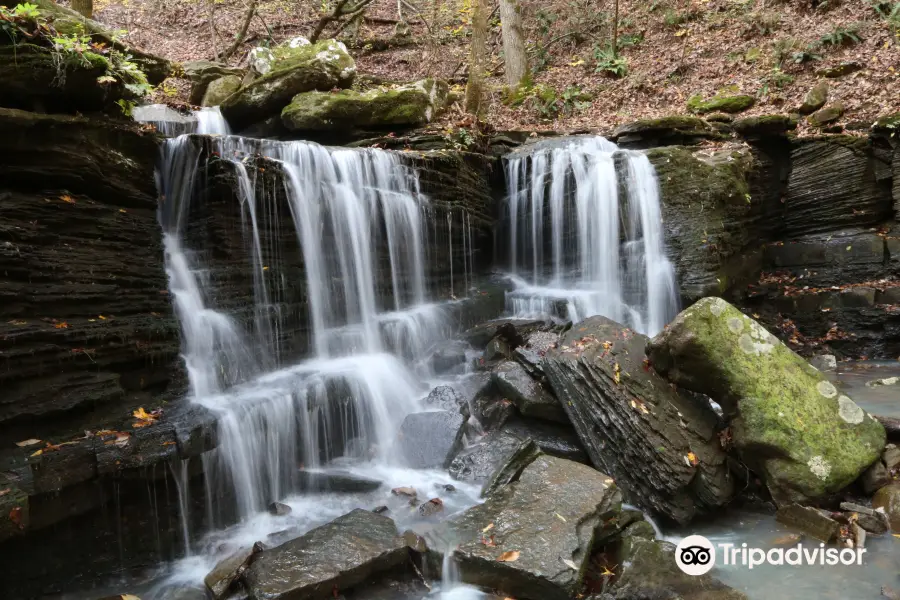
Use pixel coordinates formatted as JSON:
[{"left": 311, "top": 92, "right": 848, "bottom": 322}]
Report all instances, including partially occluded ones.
[{"left": 506, "top": 137, "right": 678, "bottom": 335}]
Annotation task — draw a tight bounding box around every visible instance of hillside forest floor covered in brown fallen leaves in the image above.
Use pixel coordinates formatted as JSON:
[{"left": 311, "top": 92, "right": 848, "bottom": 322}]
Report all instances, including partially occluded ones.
[{"left": 86, "top": 0, "right": 900, "bottom": 134}]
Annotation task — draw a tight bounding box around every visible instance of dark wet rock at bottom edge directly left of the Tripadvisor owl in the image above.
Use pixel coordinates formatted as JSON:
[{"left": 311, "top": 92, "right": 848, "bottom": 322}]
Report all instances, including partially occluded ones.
[{"left": 610, "top": 521, "right": 747, "bottom": 600}]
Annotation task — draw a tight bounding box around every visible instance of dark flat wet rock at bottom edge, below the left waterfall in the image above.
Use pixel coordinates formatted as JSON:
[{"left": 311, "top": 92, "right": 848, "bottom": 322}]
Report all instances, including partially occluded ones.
[{"left": 243, "top": 509, "right": 409, "bottom": 600}]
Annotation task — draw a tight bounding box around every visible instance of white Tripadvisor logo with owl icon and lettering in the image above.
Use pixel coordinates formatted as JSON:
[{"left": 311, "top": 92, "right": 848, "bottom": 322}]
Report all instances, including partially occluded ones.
[{"left": 675, "top": 535, "right": 866, "bottom": 575}]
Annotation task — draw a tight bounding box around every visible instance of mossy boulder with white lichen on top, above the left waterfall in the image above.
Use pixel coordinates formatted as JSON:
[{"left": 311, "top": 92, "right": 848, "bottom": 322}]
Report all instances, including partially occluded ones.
[{"left": 222, "top": 40, "right": 356, "bottom": 129}]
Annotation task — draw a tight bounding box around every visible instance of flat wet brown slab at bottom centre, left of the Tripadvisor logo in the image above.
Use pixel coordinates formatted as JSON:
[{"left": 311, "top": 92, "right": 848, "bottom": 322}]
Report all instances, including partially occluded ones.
[{"left": 426, "top": 456, "right": 621, "bottom": 600}]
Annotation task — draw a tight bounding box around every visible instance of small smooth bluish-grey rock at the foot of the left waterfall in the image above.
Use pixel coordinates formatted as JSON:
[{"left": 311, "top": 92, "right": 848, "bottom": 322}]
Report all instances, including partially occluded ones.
[{"left": 398, "top": 411, "right": 465, "bottom": 469}]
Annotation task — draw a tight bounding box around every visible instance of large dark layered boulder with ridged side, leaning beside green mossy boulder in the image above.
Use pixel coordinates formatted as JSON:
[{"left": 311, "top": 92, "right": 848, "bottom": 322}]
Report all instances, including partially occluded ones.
[{"left": 544, "top": 316, "right": 733, "bottom": 523}]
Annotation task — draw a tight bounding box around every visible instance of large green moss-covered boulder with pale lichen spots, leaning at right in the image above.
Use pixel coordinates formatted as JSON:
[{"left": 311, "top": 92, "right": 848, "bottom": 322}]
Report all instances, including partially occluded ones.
[{"left": 649, "top": 298, "right": 885, "bottom": 505}]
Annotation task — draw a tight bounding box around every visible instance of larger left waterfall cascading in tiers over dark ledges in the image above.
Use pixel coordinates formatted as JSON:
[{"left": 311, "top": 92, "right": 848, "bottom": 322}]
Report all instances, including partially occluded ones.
[{"left": 158, "top": 134, "right": 450, "bottom": 518}]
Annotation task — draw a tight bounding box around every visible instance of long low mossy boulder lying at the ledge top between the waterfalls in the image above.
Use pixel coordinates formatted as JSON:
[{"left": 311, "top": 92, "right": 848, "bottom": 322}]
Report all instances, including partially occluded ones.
[{"left": 281, "top": 79, "right": 448, "bottom": 131}]
